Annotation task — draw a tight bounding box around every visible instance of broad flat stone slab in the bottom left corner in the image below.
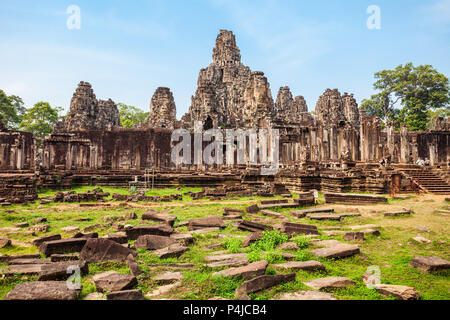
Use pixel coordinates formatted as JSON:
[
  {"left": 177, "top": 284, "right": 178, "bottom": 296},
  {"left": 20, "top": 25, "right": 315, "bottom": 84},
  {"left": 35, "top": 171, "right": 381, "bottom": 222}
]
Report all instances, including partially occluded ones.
[{"left": 5, "top": 281, "right": 79, "bottom": 300}]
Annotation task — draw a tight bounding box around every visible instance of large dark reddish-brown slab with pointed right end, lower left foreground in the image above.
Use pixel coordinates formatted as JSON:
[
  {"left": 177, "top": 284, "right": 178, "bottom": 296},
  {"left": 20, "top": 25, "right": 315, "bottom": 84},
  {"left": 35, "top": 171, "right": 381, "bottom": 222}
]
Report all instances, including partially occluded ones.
[{"left": 80, "top": 238, "right": 136, "bottom": 263}]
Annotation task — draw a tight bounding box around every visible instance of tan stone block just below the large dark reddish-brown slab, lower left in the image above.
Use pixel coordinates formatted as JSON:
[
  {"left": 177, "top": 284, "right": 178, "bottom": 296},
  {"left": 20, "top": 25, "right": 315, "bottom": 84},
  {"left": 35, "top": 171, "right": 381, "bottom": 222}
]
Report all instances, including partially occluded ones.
[{"left": 92, "top": 271, "right": 138, "bottom": 292}]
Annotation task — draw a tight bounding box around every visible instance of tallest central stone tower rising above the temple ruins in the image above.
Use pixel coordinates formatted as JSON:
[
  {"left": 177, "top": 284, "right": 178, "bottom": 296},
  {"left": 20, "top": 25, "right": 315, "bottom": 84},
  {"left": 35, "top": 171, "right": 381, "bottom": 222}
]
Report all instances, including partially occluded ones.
[{"left": 182, "top": 30, "right": 274, "bottom": 129}]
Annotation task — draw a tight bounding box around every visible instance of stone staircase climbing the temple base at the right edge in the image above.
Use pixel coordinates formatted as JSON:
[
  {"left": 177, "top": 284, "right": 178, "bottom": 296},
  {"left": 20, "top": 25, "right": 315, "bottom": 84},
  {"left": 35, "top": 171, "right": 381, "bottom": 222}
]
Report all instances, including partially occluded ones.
[{"left": 402, "top": 168, "right": 450, "bottom": 194}]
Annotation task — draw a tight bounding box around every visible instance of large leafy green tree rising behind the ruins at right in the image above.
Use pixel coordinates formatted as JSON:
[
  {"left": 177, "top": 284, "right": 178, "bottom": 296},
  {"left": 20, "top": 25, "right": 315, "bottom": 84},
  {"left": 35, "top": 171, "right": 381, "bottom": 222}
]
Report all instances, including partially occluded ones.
[{"left": 361, "top": 63, "right": 450, "bottom": 131}]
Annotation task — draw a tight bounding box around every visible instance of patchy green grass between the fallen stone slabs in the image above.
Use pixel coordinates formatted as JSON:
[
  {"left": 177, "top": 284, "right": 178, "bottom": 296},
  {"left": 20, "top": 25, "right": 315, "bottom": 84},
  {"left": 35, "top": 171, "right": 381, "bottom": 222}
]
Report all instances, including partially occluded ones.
[{"left": 0, "top": 187, "right": 450, "bottom": 300}]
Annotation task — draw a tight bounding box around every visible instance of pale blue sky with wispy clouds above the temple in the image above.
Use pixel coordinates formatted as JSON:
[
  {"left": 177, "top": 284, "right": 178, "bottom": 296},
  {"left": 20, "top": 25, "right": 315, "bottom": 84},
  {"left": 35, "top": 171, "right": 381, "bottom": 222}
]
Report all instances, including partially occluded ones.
[{"left": 0, "top": 0, "right": 450, "bottom": 118}]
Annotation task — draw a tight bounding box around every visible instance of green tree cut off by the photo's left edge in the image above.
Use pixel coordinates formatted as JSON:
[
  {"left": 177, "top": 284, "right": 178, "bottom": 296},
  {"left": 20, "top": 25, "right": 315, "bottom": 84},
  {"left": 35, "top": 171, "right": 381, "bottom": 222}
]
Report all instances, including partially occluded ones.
[{"left": 0, "top": 90, "right": 26, "bottom": 130}]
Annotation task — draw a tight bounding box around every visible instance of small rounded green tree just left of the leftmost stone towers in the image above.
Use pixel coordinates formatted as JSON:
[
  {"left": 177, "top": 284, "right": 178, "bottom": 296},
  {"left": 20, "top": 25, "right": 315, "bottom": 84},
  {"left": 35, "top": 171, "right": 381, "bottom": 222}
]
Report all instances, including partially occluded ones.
[{"left": 20, "top": 101, "right": 62, "bottom": 138}]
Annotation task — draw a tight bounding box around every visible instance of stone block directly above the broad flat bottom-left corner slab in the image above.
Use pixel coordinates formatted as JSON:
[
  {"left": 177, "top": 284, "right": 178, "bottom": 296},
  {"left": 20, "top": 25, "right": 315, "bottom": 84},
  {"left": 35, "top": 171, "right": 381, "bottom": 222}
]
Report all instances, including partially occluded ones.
[{"left": 38, "top": 261, "right": 89, "bottom": 281}]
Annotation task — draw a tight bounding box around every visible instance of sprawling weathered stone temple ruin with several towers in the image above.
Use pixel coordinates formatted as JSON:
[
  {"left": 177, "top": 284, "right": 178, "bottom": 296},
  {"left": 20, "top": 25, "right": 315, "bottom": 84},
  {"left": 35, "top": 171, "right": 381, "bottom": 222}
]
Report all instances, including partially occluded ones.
[{"left": 0, "top": 30, "right": 450, "bottom": 201}]
